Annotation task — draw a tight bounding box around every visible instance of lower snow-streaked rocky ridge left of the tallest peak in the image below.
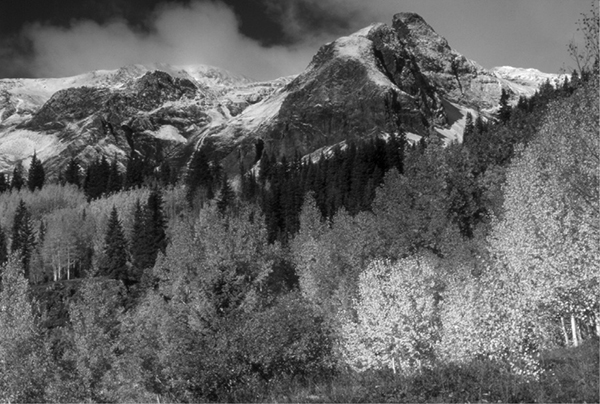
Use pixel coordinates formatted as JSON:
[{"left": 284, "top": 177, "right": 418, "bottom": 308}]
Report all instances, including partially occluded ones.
[{"left": 0, "top": 65, "right": 286, "bottom": 176}]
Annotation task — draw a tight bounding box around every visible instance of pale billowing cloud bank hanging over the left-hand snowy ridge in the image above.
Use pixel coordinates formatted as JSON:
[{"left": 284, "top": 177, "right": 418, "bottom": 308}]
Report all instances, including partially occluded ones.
[{"left": 8, "top": 2, "right": 324, "bottom": 79}]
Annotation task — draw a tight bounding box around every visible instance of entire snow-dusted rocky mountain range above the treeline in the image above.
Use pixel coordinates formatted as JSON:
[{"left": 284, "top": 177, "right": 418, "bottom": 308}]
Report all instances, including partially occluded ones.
[{"left": 0, "top": 13, "right": 562, "bottom": 175}]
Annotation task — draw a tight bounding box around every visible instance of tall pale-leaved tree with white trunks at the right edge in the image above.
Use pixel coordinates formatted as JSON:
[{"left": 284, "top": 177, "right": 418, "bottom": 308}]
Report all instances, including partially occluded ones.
[{"left": 490, "top": 77, "right": 600, "bottom": 345}]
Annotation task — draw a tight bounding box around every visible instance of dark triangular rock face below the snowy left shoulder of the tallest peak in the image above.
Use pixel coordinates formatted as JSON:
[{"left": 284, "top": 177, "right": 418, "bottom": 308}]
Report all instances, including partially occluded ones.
[{"left": 266, "top": 36, "right": 427, "bottom": 156}]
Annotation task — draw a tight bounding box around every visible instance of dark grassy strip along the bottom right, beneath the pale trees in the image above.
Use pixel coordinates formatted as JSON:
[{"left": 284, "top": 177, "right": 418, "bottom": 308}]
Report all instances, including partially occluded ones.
[{"left": 255, "top": 339, "right": 600, "bottom": 403}]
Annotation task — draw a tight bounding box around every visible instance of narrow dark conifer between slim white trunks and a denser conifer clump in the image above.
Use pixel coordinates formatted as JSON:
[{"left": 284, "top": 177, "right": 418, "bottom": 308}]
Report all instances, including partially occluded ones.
[{"left": 100, "top": 206, "right": 129, "bottom": 280}]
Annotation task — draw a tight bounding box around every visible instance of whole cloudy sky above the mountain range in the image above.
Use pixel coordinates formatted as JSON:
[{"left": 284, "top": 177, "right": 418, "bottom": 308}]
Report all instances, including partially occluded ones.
[{"left": 0, "top": 0, "right": 592, "bottom": 79}]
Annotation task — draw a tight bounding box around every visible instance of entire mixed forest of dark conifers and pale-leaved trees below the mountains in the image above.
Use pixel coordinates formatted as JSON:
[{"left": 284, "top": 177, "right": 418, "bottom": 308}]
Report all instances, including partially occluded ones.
[{"left": 0, "top": 54, "right": 600, "bottom": 402}]
